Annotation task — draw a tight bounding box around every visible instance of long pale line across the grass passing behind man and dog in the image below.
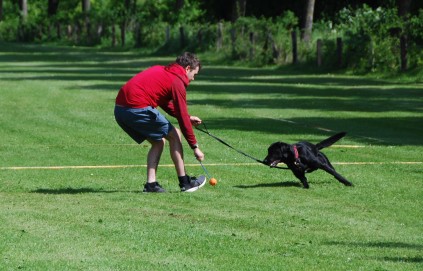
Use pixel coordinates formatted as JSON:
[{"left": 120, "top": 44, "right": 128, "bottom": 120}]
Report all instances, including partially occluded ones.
[{"left": 0, "top": 161, "right": 423, "bottom": 170}]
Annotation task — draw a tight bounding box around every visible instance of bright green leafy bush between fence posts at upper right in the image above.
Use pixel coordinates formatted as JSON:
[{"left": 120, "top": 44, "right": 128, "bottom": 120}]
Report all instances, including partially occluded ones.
[{"left": 337, "top": 5, "right": 402, "bottom": 72}]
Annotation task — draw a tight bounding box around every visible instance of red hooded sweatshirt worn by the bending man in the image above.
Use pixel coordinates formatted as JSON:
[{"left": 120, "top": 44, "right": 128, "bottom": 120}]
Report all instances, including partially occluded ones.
[{"left": 116, "top": 63, "right": 197, "bottom": 146}]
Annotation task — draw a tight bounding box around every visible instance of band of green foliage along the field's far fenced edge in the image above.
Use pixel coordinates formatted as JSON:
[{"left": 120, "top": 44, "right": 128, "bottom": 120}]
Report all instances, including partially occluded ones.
[{"left": 0, "top": 0, "right": 423, "bottom": 73}]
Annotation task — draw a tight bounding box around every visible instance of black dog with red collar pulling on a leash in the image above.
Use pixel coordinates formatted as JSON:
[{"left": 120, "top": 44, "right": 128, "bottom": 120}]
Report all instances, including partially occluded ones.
[{"left": 263, "top": 132, "right": 352, "bottom": 188}]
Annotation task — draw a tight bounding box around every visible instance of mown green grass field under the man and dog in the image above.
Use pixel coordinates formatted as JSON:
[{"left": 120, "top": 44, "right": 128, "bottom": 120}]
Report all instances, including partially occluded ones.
[{"left": 0, "top": 44, "right": 423, "bottom": 270}]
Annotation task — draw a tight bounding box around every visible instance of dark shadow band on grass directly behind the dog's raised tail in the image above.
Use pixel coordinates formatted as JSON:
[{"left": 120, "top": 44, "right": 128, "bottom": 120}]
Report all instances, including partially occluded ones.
[{"left": 197, "top": 116, "right": 423, "bottom": 146}]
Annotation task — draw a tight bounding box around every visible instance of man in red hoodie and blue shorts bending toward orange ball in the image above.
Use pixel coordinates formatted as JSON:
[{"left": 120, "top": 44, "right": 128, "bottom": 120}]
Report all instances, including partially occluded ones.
[{"left": 115, "top": 52, "right": 206, "bottom": 192}]
